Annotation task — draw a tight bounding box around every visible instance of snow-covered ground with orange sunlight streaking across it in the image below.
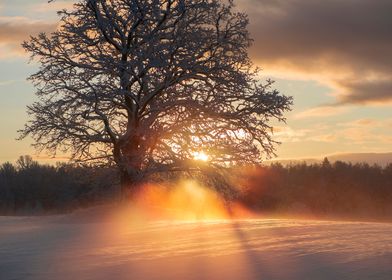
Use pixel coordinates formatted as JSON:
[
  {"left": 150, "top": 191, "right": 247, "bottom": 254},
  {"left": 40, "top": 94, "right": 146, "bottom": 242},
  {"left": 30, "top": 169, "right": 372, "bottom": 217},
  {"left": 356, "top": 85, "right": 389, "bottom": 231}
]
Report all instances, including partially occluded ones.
[{"left": 0, "top": 207, "right": 392, "bottom": 280}]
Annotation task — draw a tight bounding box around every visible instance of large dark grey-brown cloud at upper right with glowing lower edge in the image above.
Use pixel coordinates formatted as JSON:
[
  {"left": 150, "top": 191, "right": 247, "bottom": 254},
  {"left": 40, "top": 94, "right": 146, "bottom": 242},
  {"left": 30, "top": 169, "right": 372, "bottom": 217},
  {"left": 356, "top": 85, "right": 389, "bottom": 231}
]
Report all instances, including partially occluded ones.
[{"left": 237, "top": 0, "right": 392, "bottom": 104}]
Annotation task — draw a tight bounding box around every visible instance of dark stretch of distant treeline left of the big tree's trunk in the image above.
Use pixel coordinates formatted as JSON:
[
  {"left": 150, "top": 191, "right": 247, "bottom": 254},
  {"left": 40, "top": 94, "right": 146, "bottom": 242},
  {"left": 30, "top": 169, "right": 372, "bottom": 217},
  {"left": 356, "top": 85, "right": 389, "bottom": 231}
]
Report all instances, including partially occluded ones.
[{"left": 0, "top": 156, "right": 118, "bottom": 215}]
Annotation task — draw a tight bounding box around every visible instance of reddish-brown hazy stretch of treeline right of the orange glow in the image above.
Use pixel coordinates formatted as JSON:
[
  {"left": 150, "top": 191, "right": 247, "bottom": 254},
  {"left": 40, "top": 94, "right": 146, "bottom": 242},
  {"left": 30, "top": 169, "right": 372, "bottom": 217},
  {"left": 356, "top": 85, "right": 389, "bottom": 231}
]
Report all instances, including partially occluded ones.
[{"left": 240, "top": 159, "right": 392, "bottom": 221}]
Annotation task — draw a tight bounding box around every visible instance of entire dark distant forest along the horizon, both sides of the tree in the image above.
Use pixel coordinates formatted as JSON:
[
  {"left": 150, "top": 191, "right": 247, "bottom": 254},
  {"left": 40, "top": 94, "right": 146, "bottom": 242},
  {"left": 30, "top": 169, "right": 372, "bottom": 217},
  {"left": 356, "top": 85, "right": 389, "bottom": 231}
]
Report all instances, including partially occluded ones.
[{"left": 0, "top": 156, "right": 392, "bottom": 221}]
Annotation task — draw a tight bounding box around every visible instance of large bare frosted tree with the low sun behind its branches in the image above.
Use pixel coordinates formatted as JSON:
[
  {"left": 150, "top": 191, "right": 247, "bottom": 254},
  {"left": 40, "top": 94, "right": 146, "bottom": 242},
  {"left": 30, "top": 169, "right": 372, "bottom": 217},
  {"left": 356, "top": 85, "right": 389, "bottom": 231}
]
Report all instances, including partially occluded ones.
[{"left": 21, "top": 0, "right": 292, "bottom": 192}]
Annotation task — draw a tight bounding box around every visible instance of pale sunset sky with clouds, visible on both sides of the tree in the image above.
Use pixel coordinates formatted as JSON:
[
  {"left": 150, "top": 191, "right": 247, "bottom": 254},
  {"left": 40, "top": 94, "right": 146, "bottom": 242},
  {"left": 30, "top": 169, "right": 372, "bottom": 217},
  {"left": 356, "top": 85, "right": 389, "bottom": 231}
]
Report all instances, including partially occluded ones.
[{"left": 0, "top": 0, "right": 392, "bottom": 162}]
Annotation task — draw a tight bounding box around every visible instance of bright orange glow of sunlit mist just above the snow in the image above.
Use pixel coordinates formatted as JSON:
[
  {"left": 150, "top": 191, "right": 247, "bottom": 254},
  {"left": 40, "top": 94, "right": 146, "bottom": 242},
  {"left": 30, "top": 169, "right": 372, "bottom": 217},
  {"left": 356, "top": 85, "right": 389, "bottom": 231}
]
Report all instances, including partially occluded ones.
[{"left": 108, "top": 179, "right": 253, "bottom": 224}]
